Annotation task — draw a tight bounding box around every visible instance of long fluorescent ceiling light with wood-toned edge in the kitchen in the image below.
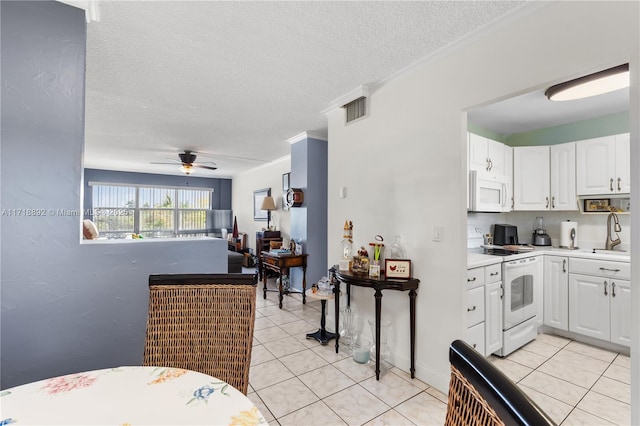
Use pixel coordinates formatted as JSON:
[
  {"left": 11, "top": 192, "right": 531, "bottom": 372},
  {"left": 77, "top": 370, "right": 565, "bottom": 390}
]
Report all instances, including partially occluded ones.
[{"left": 544, "top": 64, "right": 629, "bottom": 101}]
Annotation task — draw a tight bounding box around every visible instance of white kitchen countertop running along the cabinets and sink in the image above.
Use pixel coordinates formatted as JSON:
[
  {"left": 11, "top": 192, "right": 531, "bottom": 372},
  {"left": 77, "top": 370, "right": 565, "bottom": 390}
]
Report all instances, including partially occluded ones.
[{"left": 467, "top": 247, "right": 631, "bottom": 269}]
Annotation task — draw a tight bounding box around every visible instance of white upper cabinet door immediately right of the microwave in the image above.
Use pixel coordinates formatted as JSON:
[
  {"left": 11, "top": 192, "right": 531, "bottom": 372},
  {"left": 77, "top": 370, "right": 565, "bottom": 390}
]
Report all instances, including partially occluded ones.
[{"left": 513, "top": 146, "right": 551, "bottom": 211}]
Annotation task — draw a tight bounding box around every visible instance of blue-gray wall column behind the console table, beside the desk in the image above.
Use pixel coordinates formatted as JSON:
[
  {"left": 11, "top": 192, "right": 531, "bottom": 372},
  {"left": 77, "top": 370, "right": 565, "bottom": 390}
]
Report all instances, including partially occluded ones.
[{"left": 291, "top": 138, "right": 330, "bottom": 284}]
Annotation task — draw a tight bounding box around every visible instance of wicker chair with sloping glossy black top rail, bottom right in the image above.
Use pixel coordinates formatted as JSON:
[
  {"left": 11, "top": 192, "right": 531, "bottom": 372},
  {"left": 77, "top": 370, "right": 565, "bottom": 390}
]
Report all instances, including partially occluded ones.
[{"left": 445, "top": 340, "right": 555, "bottom": 426}]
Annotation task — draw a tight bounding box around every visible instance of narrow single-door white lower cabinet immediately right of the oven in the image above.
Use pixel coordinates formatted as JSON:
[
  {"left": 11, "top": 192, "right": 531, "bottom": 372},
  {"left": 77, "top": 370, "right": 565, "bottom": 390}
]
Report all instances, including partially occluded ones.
[{"left": 543, "top": 255, "right": 569, "bottom": 331}]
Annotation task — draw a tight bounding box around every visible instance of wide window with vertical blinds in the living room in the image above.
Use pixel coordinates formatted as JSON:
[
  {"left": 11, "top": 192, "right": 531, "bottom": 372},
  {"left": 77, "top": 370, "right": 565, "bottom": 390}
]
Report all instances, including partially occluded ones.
[{"left": 90, "top": 183, "right": 213, "bottom": 238}]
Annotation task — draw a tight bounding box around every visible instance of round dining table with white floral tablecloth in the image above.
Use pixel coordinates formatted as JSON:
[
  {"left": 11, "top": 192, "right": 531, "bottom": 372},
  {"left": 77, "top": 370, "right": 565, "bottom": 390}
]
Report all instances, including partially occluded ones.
[{"left": 0, "top": 366, "right": 267, "bottom": 426}]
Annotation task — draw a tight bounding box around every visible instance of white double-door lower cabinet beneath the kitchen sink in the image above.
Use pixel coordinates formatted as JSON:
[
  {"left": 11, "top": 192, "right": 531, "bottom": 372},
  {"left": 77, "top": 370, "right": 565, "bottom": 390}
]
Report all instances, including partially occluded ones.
[{"left": 569, "top": 259, "right": 631, "bottom": 346}]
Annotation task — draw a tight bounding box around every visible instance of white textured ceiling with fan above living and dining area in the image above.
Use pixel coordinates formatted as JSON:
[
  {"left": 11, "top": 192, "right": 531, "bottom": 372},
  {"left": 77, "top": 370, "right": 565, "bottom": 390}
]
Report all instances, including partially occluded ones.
[{"left": 85, "top": 1, "right": 524, "bottom": 177}]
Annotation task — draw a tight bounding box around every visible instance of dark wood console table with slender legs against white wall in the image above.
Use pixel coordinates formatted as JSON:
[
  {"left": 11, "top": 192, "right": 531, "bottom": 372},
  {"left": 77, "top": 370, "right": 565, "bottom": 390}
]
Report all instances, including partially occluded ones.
[{"left": 330, "top": 266, "right": 420, "bottom": 380}]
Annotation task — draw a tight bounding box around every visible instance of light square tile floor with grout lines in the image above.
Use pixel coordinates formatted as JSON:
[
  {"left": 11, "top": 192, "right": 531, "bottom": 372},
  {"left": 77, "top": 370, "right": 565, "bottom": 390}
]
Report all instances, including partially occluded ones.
[{"left": 248, "top": 283, "right": 631, "bottom": 426}]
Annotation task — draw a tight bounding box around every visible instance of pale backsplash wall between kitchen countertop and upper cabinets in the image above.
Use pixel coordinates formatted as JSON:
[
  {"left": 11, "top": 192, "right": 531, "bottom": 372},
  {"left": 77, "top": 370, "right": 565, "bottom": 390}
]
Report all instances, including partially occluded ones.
[{"left": 467, "top": 212, "right": 631, "bottom": 251}]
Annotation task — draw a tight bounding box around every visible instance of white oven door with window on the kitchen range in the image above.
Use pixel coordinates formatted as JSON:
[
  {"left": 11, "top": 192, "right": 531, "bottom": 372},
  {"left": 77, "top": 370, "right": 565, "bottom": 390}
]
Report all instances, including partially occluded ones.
[{"left": 503, "top": 257, "right": 538, "bottom": 330}]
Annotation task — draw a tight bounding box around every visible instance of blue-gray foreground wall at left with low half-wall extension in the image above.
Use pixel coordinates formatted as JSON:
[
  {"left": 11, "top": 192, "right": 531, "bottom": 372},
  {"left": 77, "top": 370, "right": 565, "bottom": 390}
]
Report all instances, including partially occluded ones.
[{"left": 0, "top": 1, "right": 227, "bottom": 389}]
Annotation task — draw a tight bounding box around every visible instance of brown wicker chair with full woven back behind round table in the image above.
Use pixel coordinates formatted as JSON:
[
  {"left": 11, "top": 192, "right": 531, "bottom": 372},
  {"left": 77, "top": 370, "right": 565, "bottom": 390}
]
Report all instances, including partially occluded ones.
[{"left": 143, "top": 274, "right": 256, "bottom": 394}]
